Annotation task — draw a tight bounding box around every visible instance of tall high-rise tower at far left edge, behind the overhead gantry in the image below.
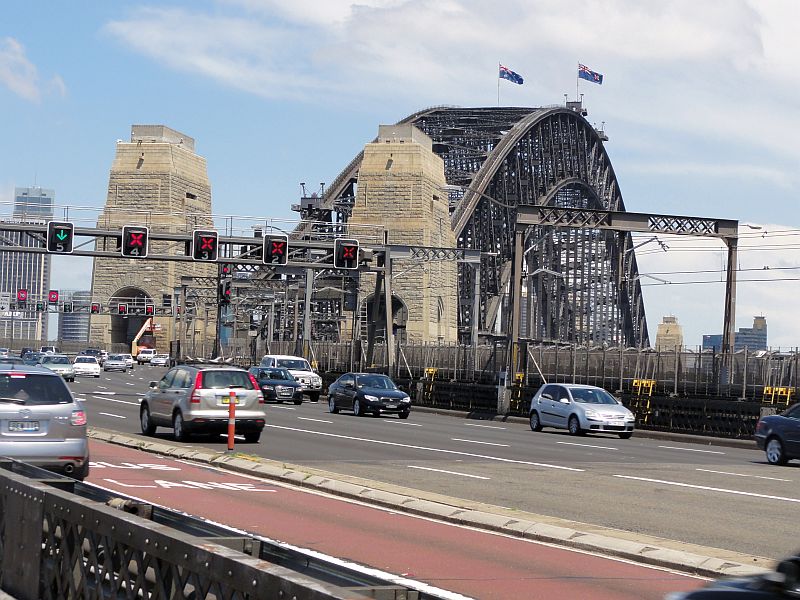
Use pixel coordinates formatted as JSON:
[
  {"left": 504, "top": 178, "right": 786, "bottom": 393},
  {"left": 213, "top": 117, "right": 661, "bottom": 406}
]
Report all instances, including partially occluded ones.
[{"left": 0, "top": 187, "right": 55, "bottom": 340}]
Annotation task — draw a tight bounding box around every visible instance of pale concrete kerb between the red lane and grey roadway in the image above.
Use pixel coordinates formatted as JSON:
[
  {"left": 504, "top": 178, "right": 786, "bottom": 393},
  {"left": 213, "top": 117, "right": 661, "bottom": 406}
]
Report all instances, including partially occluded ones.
[{"left": 89, "top": 427, "right": 774, "bottom": 577}]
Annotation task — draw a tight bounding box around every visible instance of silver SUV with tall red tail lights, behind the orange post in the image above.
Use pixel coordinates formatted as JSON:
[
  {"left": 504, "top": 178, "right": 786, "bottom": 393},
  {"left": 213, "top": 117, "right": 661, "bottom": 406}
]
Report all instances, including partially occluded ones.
[{"left": 139, "top": 364, "right": 266, "bottom": 443}]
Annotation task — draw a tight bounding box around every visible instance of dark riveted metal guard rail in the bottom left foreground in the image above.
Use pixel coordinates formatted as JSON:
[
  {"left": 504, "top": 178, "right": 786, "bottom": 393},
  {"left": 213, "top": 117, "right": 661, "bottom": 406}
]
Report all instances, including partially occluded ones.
[{"left": 0, "top": 457, "right": 428, "bottom": 600}]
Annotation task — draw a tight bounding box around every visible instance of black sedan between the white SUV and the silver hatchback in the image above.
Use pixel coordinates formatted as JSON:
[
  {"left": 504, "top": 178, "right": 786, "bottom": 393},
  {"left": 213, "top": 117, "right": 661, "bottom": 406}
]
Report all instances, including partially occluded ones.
[{"left": 328, "top": 373, "right": 411, "bottom": 419}]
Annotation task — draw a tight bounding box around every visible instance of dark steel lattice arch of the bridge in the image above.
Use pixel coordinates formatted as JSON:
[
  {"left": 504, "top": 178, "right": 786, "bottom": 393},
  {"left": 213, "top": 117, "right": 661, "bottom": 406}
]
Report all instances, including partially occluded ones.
[{"left": 296, "top": 106, "right": 649, "bottom": 347}]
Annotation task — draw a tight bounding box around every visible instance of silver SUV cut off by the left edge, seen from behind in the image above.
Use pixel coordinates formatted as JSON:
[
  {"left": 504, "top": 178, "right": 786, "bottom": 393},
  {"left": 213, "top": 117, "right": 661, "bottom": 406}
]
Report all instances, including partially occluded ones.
[{"left": 0, "top": 364, "right": 89, "bottom": 481}]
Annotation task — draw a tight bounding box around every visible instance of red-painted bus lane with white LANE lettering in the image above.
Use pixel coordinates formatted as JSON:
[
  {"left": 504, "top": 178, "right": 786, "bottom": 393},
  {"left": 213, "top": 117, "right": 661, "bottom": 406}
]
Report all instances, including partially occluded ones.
[{"left": 88, "top": 440, "right": 703, "bottom": 600}]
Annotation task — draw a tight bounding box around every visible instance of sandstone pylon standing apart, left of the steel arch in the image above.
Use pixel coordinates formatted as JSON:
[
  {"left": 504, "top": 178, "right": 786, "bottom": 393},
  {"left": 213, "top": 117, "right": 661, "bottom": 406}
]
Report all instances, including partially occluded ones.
[{"left": 89, "top": 125, "right": 217, "bottom": 355}]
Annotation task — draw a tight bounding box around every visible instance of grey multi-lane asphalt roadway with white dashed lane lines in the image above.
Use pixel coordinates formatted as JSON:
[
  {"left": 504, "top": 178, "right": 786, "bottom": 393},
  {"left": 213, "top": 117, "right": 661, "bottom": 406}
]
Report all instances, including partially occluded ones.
[{"left": 70, "top": 367, "right": 800, "bottom": 559}]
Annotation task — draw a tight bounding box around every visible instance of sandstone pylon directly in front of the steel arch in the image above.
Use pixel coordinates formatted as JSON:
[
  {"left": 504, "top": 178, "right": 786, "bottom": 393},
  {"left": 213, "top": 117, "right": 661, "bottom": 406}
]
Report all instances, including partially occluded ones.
[{"left": 348, "top": 125, "right": 458, "bottom": 343}]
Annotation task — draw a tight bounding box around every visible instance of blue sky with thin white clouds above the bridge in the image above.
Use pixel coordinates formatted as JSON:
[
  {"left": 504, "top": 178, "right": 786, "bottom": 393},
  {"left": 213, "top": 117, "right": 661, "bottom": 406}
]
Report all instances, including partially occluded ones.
[{"left": 0, "top": 0, "right": 800, "bottom": 348}]
